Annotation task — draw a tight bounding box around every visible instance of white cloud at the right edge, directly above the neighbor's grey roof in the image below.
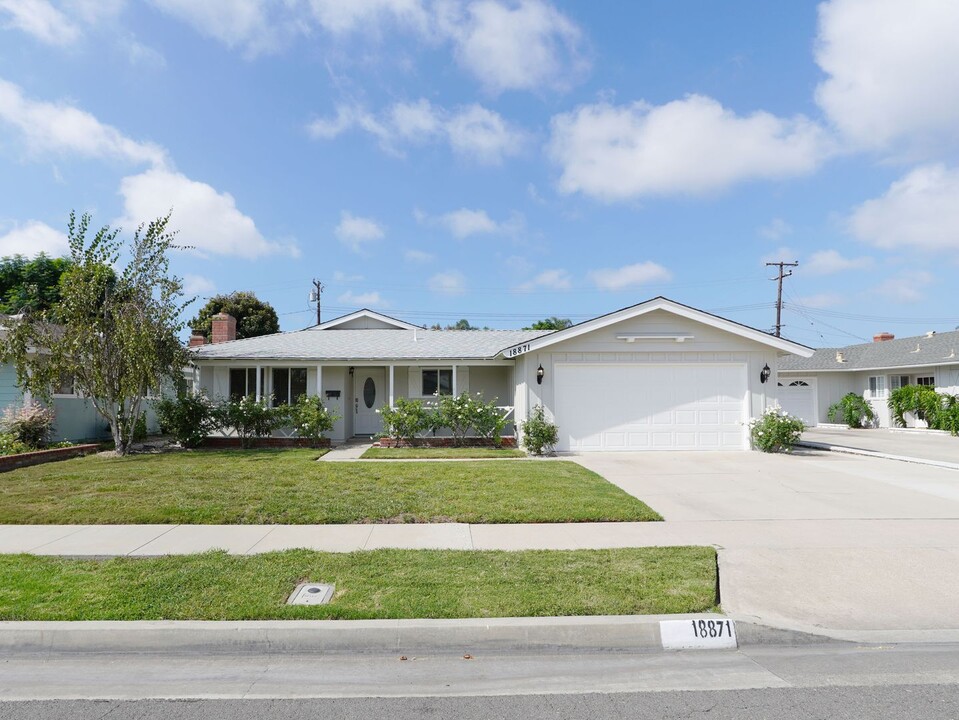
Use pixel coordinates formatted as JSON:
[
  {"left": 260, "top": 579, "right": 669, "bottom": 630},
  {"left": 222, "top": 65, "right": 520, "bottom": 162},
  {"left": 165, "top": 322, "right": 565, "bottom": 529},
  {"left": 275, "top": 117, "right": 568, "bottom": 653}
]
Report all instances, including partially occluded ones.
[{"left": 849, "top": 165, "right": 959, "bottom": 251}]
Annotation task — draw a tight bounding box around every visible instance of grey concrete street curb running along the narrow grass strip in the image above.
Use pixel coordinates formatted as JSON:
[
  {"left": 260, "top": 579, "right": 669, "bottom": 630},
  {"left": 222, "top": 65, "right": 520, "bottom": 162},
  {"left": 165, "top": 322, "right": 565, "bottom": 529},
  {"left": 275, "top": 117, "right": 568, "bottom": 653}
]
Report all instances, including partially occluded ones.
[{"left": 0, "top": 613, "right": 829, "bottom": 654}]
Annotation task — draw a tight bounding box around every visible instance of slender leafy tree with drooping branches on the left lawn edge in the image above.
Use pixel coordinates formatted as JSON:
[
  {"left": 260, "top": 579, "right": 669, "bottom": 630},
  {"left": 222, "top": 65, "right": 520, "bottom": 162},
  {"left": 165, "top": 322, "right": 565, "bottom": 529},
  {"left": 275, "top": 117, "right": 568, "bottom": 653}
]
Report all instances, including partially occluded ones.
[{"left": 3, "top": 213, "right": 189, "bottom": 455}]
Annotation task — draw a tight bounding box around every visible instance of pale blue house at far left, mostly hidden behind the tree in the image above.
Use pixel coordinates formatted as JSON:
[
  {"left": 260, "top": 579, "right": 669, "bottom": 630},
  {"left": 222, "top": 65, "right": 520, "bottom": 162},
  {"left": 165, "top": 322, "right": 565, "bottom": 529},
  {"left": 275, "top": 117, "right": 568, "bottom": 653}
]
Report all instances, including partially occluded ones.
[{"left": 0, "top": 316, "right": 159, "bottom": 442}]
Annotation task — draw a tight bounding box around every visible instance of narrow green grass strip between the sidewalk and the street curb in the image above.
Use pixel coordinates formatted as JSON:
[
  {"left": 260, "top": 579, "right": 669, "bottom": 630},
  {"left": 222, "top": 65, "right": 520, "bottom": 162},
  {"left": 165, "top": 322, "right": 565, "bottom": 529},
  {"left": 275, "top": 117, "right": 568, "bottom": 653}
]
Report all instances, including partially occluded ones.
[{"left": 0, "top": 547, "right": 716, "bottom": 620}]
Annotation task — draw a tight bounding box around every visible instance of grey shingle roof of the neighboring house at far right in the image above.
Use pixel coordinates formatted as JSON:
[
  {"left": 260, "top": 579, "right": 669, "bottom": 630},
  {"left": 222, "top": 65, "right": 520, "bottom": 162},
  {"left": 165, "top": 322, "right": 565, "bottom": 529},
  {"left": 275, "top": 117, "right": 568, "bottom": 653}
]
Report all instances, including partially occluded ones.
[{"left": 779, "top": 331, "right": 959, "bottom": 372}]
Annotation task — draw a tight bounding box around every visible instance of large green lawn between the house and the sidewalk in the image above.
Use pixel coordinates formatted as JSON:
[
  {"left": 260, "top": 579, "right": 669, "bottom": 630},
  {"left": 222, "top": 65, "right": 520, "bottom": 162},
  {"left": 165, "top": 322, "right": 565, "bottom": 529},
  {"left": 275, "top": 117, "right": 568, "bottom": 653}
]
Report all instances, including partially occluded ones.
[{"left": 0, "top": 450, "right": 662, "bottom": 525}]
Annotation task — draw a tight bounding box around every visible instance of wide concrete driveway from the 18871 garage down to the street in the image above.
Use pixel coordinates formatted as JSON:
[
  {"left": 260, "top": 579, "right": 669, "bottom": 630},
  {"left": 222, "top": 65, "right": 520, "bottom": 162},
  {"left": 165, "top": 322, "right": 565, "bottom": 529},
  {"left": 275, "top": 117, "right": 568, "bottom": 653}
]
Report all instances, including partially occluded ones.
[{"left": 573, "top": 451, "right": 959, "bottom": 641}]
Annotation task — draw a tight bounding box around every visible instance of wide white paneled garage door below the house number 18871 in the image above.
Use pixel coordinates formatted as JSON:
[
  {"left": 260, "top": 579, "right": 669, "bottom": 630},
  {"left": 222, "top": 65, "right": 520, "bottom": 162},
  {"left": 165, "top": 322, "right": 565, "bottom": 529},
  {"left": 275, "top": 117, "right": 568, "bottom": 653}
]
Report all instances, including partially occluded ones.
[{"left": 555, "top": 363, "right": 746, "bottom": 452}]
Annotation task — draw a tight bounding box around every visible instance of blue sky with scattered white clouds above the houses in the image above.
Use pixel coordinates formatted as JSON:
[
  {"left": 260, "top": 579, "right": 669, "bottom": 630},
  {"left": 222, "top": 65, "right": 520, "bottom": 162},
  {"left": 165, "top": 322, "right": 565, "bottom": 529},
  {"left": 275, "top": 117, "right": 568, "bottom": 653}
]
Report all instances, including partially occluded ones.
[{"left": 0, "top": 0, "right": 959, "bottom": 346}]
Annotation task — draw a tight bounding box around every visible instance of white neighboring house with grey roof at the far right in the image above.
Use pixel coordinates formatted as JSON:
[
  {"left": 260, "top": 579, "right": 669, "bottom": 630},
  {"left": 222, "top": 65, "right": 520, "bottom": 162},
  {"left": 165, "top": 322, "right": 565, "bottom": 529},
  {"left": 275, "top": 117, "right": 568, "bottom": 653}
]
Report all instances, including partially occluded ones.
[{"left": 778, "top": 331, "right": 959, "bottom": 427}]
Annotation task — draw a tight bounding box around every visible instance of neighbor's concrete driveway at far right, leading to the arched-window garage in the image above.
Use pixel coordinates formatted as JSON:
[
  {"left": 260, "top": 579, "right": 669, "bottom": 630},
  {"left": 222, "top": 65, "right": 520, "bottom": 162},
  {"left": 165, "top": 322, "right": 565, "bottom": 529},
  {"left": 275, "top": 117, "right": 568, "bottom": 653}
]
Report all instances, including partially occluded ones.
[{"left": 802, "top": 427, "right": 959, "bottom": 465}]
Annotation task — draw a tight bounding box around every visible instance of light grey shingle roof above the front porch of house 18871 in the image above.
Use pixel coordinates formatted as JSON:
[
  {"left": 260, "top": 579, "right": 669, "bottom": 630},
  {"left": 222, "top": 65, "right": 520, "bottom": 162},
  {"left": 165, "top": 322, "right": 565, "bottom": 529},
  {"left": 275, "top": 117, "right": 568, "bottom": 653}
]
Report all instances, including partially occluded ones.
[{"left": 190, "top": 328, "right": 548, "bottom": 360}]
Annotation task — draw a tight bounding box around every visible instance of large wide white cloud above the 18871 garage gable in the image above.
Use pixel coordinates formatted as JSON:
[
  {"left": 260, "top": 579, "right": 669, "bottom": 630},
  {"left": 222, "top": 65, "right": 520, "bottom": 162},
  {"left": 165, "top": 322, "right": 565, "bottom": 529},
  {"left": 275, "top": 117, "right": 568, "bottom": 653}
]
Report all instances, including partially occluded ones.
[{"left": 548, "top": 95, "right": 828, "bottom": 201}]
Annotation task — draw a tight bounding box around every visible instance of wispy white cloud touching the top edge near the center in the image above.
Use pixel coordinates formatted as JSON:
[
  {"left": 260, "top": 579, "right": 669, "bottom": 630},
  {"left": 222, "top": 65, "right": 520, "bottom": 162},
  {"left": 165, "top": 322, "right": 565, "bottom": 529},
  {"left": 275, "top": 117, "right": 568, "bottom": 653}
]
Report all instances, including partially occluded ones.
[{"left": 438, "top": 0, "right": 589, "bottom": 93}]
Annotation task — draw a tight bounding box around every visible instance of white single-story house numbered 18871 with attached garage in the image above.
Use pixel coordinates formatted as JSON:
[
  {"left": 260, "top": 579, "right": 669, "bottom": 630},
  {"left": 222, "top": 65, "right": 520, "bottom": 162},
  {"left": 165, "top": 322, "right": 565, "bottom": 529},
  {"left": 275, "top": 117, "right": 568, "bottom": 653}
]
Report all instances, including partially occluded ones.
[{"left": 193, "top": 297, "right": 813, "bottom": 451}]
